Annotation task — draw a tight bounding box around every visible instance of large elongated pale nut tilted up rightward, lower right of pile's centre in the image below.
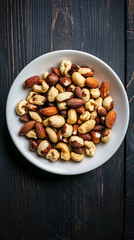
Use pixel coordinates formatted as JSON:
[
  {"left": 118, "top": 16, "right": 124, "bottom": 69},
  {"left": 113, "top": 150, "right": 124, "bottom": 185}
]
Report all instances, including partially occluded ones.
[{"left": 78, "top": 119, "right": 95, "bottom": 134}]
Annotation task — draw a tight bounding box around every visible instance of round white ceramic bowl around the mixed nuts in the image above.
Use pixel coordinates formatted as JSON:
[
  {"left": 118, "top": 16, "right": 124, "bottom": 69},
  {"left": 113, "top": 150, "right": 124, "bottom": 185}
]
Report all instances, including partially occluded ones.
[{"left": 6, "top": 50, "right": 129, "bottom": 175}]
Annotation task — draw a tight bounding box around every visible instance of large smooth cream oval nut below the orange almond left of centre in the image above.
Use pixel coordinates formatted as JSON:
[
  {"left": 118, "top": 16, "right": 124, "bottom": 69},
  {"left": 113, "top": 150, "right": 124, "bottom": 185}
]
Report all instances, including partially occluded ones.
[{"left": 48, "top": 115, "right": 65, "bottom": 128}]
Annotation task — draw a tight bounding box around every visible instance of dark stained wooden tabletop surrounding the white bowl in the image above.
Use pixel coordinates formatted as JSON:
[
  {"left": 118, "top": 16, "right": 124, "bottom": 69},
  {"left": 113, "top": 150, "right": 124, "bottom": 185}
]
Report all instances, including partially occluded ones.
[{"left": 0, "top": 0, "right": 134, "bottom": 240}]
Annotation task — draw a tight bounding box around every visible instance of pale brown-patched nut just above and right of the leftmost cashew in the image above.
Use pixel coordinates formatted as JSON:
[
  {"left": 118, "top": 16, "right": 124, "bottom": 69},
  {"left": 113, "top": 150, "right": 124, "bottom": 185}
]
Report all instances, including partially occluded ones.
[{"left": 27, "top": 92, "right": 46, "bottom": 106}]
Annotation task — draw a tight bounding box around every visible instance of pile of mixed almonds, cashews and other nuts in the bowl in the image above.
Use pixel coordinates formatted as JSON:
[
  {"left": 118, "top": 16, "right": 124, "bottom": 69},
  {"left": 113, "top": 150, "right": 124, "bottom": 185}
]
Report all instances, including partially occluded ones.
[{"left": 16, "top": 60, "right": 116, "bottom": 162}]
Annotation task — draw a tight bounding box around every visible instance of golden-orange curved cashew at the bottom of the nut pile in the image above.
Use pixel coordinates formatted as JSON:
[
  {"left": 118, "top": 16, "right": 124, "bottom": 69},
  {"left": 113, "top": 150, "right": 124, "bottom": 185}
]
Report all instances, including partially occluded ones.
[{"left": 56, "top": 142, "right": 70, "bottom": 161}]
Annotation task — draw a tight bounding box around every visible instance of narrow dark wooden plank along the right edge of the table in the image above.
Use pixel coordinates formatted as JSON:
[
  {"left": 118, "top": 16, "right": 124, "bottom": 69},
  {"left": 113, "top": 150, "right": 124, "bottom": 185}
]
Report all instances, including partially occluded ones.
[{"left": 125, "top": 30, "right": 134, "bottom": 240}]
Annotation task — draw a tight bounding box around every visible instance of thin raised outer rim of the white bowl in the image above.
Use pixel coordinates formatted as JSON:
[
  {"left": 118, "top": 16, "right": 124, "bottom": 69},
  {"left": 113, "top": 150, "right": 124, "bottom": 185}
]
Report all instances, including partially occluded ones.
[{"left": 6, "top": 49, "right": 129, "bottom": 175}]
